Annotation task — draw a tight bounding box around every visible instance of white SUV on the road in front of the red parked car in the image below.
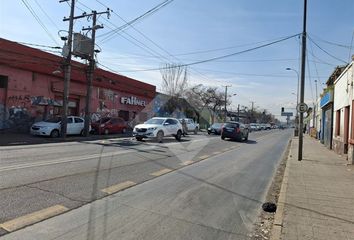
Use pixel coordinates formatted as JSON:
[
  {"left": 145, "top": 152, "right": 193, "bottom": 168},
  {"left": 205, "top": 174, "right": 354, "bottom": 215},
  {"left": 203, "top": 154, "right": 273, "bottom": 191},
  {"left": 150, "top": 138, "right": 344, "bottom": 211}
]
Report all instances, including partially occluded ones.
[{"left": 133, "top": 117, "right": 182, "bottom": 142}]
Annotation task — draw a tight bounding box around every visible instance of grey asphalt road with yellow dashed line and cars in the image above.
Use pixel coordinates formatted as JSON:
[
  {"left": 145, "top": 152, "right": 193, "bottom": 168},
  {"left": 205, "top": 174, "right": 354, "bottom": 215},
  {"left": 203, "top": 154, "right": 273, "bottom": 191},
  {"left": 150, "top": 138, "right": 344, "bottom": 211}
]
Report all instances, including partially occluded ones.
[{"left": 0, "top": 130, "right": 291, "bottom": 240}]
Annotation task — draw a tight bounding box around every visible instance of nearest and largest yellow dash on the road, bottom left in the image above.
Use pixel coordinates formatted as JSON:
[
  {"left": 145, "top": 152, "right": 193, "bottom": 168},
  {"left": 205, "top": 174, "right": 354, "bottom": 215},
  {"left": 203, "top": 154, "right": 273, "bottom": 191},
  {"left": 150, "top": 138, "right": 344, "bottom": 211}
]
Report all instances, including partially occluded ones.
[{"left": 0, "top": 205, "right": 69, "bottom": 232}]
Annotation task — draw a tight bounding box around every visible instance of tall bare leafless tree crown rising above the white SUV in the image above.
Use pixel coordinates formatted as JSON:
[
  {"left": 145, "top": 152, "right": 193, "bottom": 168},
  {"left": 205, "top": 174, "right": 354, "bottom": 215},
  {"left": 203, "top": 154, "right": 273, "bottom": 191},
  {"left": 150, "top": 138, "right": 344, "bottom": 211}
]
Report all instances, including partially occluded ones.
[{"left": 160, "top": 63, "right": 188, "bottom": 98}]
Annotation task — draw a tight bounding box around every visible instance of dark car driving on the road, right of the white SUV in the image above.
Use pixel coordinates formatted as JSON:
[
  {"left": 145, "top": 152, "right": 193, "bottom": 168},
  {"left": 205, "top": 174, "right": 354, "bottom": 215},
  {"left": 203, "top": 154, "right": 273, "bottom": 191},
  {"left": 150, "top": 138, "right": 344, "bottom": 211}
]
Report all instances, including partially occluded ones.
[{"left": 221, "top": 122, "right": 249, "bottom": 141}]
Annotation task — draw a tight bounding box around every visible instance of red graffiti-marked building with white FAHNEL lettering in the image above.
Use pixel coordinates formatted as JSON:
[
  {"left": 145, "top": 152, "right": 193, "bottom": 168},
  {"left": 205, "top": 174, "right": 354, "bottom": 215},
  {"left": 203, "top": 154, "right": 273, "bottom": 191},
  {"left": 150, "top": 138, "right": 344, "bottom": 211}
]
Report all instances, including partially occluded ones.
[{"left": 0, "top": 38, "right": 156, "bottom": 129}]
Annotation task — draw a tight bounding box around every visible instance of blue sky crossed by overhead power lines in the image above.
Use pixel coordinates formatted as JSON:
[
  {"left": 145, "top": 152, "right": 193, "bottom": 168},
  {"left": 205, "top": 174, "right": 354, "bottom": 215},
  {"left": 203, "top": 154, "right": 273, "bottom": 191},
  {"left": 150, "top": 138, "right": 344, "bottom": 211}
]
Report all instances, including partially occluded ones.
[{"left": 0, "top": 0, "right": 354, "bottom": 119}]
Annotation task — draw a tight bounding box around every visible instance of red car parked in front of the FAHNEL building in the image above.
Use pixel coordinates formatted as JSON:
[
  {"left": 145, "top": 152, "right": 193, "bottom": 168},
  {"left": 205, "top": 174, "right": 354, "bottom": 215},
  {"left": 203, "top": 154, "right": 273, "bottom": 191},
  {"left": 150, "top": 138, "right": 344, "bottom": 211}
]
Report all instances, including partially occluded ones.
[{"left": 91, "top": 117, "right": 129, "bottom": 134}]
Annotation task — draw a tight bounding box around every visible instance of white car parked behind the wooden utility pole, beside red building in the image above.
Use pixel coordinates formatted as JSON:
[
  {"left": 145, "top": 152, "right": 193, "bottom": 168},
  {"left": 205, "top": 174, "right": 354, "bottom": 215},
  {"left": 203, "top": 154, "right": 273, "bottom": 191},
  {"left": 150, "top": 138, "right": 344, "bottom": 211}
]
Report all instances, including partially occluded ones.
[{"left": 31, "top": 116, "right": 85, "bottom": 138}]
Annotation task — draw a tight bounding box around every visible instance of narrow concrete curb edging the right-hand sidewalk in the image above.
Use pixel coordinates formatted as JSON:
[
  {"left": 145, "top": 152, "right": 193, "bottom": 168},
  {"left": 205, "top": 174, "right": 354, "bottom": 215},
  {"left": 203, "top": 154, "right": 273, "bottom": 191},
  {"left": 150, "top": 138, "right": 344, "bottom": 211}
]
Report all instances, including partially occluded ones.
[{"left": 270, "top": 139, "right": 294, "bottom": 240}]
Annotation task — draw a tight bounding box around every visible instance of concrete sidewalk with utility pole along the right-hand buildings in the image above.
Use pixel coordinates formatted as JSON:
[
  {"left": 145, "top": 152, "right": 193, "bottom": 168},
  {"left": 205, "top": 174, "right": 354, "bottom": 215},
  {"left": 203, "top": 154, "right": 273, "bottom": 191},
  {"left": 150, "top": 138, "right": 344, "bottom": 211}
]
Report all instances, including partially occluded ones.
[{"left": 271, "top": 136, "right": 354, "bottom": 240}]
